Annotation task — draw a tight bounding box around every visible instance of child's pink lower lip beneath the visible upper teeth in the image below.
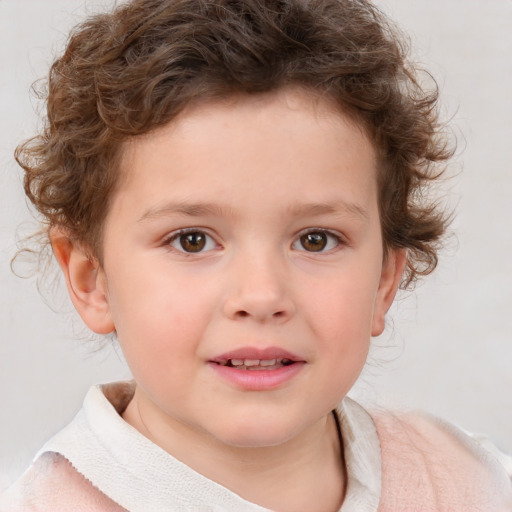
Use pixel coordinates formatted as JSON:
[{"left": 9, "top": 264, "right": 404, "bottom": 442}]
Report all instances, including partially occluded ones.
[{"left": 210, "top": 362, "right": 304, "bottom": 391}]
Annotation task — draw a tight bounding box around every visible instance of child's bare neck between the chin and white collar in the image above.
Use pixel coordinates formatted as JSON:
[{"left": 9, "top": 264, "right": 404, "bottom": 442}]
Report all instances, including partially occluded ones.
[{"left": 123, "top": 386, "right": 346, "bottom": 512}]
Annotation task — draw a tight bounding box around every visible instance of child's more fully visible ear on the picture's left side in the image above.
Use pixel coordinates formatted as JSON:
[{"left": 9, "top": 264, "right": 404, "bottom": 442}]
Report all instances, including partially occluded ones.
[{"left": 50, "top": 228, "right": 115, "bottom": 334}]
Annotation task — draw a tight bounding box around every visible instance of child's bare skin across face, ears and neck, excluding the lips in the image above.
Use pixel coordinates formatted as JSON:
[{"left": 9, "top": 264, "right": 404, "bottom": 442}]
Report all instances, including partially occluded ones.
[{"left": 52, "top": 89, "right": 405, "bottom": 511}]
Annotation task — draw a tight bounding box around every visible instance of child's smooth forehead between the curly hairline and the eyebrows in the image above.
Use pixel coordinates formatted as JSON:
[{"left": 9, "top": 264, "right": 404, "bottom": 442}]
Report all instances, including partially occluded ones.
[{"left": 116, "top": 89, "right": 376, "bottom": 218}]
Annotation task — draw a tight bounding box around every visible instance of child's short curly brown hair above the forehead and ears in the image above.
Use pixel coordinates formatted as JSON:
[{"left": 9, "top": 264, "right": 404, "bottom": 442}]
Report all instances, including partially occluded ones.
[{"left": 16, "top": 0, "right": 452, "bottom": 286}]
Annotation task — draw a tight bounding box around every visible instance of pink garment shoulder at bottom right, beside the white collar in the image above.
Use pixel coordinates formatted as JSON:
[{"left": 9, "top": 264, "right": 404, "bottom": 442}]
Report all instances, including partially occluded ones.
[{"left": 372, "top": 412, "right": 512, "bottom": 512}]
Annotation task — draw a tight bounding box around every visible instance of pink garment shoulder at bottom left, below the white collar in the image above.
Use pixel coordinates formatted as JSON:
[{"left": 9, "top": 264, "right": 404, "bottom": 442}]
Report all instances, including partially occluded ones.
[{"left": 0, "top": 452, "right": 123, "bottom": 512}]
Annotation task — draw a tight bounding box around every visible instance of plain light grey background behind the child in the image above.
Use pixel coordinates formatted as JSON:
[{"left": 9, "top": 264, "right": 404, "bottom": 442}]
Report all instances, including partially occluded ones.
[{"left": 0, "top": 0, "right": 512, "bottom": 487}]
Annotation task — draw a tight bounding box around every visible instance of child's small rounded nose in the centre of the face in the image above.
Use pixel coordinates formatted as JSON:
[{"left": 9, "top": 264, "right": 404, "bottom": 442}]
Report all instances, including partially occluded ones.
[{"left": 224, "top": 249, "right": 295, "bottom": 324}]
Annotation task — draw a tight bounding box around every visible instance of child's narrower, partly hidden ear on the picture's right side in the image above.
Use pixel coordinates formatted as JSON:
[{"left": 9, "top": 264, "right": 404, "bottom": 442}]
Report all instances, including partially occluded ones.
[{"left": 372, "top": 249, "right": 407, "bottom": 336}]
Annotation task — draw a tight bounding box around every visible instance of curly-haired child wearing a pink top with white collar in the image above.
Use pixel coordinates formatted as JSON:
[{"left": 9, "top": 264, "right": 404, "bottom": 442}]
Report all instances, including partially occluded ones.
[{"left": 1, "top": 0, "right": 512, "bottom": 511}]
